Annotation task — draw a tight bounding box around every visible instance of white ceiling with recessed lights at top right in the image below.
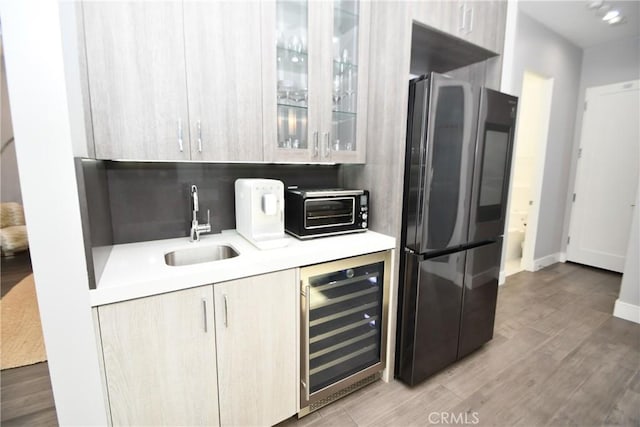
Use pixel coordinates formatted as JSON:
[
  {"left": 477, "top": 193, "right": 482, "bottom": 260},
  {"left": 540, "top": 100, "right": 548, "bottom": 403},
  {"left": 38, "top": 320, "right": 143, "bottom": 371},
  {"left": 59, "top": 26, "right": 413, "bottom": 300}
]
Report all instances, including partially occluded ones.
[{"left": 517, "top": 1, "right": 640, "bottom": 48}]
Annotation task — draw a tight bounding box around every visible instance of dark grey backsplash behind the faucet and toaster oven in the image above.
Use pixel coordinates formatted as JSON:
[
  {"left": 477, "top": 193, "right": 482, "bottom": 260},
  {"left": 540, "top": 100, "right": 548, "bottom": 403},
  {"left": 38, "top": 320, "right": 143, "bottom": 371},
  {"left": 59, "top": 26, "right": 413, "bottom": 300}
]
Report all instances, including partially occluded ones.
[{"left": 85, "top": 160, "right": 339, "bottom": 246}]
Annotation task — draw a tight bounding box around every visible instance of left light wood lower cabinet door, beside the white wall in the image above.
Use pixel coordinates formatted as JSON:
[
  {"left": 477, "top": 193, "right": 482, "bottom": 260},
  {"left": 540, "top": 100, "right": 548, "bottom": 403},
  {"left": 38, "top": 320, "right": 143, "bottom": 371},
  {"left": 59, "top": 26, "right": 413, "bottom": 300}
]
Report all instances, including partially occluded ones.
[{"left": 98, "top": 285, "right": 219, "bottom": 426}]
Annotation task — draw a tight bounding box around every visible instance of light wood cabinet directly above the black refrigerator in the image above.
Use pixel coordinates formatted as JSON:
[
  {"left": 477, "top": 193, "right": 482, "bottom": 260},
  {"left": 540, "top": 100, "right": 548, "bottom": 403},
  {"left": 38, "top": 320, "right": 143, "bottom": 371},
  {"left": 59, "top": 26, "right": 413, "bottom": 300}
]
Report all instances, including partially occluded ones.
[{"left": 411, "top": 0, "right": 507, "bottom": 53}]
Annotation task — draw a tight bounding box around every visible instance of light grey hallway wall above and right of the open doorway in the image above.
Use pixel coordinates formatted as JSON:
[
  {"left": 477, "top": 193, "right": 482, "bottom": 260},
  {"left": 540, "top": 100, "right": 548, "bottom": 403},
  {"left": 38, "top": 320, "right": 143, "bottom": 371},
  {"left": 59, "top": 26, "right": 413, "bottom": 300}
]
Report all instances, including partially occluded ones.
[{"left": 502, "top": 12, "right": 582, "bottom": 259}]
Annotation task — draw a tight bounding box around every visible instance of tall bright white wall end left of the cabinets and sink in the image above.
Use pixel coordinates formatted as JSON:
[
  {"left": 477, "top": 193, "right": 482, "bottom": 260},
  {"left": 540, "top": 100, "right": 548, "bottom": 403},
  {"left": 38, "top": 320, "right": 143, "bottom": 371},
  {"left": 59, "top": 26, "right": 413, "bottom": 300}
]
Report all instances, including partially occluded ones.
[{"left": 0, "top": 0, "right": 107, "bottom": 426}]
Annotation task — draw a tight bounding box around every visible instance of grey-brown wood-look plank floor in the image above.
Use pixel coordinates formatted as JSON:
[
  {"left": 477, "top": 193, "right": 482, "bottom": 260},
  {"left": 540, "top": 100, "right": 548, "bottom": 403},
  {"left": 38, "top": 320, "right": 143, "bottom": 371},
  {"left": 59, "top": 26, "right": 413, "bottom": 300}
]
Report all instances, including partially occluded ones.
[{"left": 2, "top": 263, "right": 640, "bottom": 426}]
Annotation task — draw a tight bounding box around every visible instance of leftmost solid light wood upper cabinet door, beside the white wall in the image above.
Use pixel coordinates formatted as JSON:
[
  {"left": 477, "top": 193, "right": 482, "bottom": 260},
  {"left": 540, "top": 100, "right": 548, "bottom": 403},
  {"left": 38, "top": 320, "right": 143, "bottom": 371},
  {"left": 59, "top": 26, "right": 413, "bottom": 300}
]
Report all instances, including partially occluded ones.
[{"left": 82, "top": 2, "right": 190, "bottom": 160}]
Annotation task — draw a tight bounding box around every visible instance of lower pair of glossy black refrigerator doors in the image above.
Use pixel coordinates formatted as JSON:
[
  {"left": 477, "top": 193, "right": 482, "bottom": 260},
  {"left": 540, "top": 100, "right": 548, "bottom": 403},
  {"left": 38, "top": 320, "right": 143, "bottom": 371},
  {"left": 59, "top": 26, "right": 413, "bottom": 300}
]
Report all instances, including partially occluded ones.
[{"left": 396, "top": 239, "right": 502, "bottom": 385}]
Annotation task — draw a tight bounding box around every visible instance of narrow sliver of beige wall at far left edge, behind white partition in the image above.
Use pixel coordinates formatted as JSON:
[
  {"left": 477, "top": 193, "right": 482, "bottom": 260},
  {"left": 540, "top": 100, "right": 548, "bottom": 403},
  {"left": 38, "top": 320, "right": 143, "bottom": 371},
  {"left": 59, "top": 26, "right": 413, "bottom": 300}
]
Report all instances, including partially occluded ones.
[{"left": 0, "top": 48, "right": 22, "bottom": 203}]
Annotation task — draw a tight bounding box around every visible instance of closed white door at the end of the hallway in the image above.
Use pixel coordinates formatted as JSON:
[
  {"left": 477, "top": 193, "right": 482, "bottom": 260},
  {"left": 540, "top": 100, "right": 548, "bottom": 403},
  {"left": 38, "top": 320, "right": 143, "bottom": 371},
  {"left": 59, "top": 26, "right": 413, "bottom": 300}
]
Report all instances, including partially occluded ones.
[{"left": 567, "top": 80, "right": 640, "bottom": 272}]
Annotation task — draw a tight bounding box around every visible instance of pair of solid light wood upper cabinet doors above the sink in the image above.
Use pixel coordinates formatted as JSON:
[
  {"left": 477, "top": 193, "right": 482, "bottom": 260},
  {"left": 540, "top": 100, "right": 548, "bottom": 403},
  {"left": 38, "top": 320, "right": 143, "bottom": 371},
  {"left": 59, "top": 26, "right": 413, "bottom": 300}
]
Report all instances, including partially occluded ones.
[{"left": 82, "top": 1, "right": 263, "bottom": 161}]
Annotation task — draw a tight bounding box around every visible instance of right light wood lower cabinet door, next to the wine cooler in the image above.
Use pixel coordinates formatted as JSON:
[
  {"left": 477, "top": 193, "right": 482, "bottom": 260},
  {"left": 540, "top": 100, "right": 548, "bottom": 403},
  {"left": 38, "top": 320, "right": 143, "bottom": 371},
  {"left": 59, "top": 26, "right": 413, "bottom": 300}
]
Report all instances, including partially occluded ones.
[{"left": 214, "top": 270, "right": 300, "bottom": 426}]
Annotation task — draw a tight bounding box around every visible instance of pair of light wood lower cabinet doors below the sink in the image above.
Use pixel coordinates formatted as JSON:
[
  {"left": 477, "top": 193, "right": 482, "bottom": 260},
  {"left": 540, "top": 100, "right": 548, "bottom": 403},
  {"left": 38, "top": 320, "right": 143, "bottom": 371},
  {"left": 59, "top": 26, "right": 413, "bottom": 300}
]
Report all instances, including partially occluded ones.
[{"left": 97, "top": 269, "right": 299, "bottom": 426}]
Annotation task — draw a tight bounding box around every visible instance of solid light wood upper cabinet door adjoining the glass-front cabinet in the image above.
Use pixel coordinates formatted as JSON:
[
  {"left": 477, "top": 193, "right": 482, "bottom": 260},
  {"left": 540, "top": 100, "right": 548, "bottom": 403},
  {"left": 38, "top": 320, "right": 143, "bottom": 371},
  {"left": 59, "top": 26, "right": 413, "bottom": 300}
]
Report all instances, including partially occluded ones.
[{"left": 184, "top": 1, "right": 263, "bottom": 161}]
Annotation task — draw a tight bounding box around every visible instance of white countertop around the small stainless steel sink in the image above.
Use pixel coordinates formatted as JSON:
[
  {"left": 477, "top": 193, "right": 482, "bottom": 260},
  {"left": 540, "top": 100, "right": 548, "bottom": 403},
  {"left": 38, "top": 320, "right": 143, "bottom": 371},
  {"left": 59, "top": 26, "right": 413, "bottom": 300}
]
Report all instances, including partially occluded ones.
[{"left": 89, "top": 230, "right": 395, "bottom": 306}]
